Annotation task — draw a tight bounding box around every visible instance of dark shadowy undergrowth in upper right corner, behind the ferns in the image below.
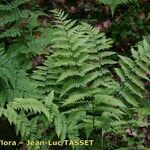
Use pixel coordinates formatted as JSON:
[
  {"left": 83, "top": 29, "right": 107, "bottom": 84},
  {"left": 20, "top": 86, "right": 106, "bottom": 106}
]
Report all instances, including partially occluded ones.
[{"left": 105, "top": 2, "right": 150, "bottom": 53}]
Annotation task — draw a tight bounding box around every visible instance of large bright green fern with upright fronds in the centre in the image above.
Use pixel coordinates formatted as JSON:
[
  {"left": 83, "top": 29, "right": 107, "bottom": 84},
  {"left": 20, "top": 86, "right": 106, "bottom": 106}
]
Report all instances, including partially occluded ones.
[{"left": 32, "top": 10, "right": 125, "bottom": 144}]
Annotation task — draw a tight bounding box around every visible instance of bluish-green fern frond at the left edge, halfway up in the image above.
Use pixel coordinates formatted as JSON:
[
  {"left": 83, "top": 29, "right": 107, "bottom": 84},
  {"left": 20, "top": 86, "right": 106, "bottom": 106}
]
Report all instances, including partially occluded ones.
[{"left": 0, "top": 48, "right": 39, "bottom": 106}]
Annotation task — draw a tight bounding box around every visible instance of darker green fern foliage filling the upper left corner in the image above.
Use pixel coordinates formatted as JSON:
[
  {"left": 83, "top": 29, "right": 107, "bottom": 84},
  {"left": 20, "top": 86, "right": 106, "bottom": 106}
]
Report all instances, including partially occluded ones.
[{"left": 0, "top": 0, "right": 49, "bottom": 69}]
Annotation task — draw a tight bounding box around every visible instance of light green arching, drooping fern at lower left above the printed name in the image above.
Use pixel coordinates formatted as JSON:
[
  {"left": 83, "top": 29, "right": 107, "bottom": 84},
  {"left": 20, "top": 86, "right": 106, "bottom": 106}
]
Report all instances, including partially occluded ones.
[{"left": 0, "top": 92, "right": 62, "bottom": 146}]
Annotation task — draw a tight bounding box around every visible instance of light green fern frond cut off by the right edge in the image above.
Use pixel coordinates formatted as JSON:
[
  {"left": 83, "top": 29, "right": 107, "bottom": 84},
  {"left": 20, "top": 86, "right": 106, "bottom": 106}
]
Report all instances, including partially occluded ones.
[{"left": 116, "top": 40, "right": 150, "bottom": 106}]
